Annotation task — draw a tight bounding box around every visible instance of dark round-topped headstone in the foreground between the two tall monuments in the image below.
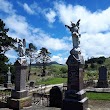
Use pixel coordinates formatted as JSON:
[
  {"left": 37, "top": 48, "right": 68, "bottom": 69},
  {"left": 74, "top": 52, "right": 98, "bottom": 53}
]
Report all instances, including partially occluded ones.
[{"left": 49, "top": 86, "right": 62, "bottom": 108}]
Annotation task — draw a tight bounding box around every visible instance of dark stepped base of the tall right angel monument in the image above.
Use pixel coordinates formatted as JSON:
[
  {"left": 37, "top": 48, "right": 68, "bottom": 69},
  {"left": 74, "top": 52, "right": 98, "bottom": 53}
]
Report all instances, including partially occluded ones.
[{"left": 62, "top": 90, "right": 88, "bottom": 110}]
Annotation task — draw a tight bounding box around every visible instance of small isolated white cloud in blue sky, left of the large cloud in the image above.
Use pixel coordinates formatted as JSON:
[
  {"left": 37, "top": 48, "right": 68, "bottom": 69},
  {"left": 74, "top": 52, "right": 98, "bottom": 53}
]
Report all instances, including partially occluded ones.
[{"left": 45, "top": 9, "right": 56, "bottom": 23}]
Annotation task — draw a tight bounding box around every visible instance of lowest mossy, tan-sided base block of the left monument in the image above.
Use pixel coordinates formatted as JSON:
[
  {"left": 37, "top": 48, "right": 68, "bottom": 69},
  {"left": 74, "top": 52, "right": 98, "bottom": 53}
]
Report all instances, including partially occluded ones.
[{"left": 7, "top": 97, "right": 32, "bottom": 110}]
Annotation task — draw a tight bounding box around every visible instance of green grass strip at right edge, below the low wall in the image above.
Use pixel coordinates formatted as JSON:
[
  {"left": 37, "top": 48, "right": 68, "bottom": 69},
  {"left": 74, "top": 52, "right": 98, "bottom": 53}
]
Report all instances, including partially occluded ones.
[{"left": 86, "top": 92, "right": 110, "bottom": 101}]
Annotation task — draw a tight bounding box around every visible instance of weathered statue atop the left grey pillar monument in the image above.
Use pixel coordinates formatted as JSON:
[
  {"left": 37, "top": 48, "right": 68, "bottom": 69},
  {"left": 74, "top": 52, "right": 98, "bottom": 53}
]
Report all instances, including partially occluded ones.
[{"left": 17, "top": 39, "right": 26, "bottom": 57}]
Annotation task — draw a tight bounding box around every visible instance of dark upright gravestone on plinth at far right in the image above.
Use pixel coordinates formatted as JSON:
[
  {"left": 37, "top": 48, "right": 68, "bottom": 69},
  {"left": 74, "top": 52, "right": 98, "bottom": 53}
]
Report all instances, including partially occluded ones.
[{"left": 97, "top": 66, "right": 108, "bottom": 88}]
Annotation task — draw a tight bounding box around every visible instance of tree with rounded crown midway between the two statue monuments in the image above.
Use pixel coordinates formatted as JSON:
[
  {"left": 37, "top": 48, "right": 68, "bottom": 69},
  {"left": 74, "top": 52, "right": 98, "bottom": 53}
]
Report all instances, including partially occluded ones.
[{"left": 37, "top": 47, "right": 51, "bottom": 76}]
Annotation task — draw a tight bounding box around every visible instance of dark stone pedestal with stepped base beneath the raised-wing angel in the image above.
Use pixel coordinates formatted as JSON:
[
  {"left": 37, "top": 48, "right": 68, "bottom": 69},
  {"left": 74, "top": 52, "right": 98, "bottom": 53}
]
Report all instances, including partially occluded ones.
[{"left": 62, "top": 54, "right": 88, "bottom": 110}]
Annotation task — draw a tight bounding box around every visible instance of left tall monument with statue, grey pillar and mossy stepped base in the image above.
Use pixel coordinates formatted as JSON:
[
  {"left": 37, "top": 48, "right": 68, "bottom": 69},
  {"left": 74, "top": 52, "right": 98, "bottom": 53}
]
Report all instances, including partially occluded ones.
[{"left": 7, "top": 39, "right": 31, "bottom": 110}]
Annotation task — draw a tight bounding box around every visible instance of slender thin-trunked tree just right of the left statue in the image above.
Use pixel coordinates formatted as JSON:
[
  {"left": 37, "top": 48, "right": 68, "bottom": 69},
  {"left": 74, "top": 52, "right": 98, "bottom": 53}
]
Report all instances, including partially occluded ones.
[{"left": 26, "top": 43, "right": 37, "bottom": 80}]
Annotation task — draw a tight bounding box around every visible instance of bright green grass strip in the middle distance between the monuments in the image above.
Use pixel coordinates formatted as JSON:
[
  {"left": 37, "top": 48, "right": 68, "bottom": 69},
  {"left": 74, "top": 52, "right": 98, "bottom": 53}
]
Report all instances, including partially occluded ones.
[{"left": 37, "top": 78, "right": 67, "bottom": 85}]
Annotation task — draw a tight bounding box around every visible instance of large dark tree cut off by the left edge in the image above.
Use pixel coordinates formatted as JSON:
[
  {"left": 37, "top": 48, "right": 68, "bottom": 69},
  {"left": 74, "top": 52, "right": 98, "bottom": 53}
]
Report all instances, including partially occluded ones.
[{"left": 0, "top": 19, "right": 16, "bottom": 82}]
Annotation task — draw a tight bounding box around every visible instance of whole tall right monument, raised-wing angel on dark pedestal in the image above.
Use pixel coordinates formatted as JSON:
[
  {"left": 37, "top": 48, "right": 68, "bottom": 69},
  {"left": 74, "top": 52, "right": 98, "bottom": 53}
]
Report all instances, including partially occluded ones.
[{"left": 62, "top": 20, "right": 88, "bottom": 110}]
